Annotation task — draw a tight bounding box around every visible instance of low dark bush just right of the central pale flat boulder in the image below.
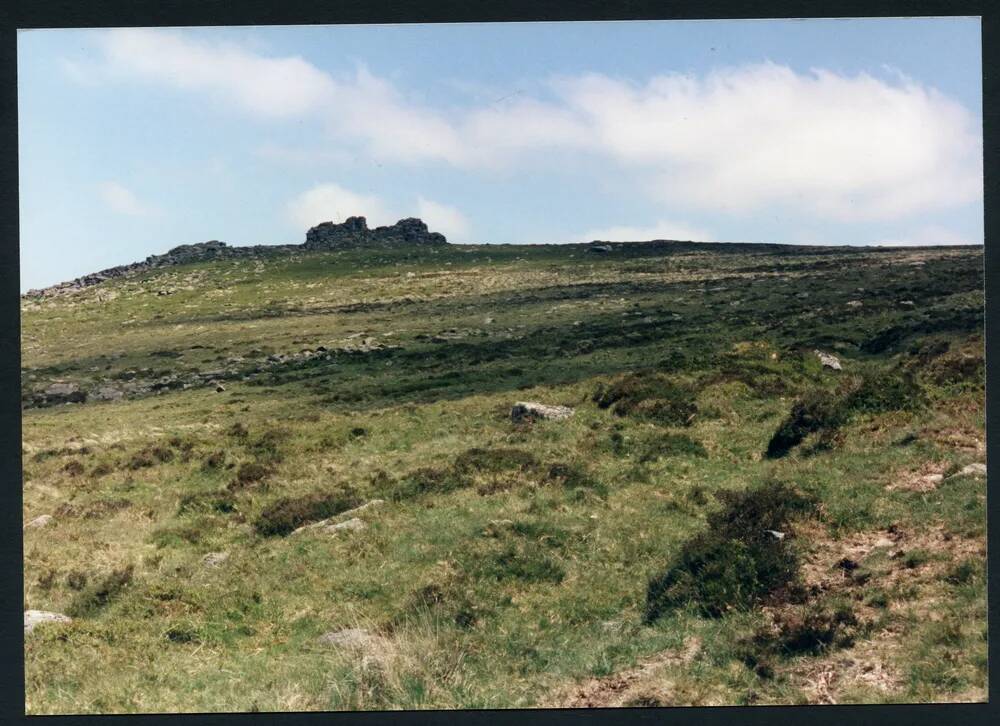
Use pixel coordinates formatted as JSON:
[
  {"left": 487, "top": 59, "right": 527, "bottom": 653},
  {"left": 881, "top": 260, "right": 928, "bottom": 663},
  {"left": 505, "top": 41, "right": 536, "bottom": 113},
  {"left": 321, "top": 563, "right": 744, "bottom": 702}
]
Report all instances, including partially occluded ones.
[{"left": 591, "top": 373, "right": 698, "bottom": 426}]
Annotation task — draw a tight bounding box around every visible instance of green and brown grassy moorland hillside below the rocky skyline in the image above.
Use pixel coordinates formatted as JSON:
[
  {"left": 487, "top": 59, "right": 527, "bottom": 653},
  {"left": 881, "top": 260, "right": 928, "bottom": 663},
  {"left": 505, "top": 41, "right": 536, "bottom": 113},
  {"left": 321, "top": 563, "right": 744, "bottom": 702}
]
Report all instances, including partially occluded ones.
[{"left": 22, "top": 243, "right": 986, "bottom": 714}]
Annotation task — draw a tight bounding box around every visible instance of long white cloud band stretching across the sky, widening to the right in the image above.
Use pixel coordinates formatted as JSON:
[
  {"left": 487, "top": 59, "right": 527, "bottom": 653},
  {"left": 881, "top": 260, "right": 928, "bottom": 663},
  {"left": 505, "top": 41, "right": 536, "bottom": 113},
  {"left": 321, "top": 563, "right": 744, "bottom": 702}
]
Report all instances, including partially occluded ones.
[{"left": 86, "top": 29, "right": 982, "bottom": 221}]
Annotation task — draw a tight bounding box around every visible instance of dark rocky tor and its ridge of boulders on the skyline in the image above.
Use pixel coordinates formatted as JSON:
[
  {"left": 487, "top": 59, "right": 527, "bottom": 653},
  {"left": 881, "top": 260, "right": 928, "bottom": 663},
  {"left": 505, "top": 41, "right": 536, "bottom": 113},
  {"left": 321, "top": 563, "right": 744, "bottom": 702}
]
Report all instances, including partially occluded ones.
[{"left": 22, "top": 217, "right": 448, "bottom": 298}]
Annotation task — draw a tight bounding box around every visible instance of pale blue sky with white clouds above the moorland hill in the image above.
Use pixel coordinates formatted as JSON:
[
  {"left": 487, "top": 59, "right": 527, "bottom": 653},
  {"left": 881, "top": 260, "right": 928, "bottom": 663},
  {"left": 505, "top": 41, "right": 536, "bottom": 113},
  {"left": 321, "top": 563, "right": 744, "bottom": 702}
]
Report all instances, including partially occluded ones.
[{"left": 18, "top": 18, "right": 983, "bottom": 290}]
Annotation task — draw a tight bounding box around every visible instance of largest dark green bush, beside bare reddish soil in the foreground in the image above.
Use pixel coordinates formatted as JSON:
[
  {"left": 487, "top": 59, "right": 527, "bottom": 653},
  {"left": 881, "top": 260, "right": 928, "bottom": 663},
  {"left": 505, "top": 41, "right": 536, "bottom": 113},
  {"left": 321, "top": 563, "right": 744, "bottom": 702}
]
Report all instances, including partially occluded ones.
[{"left": 645, "top": 483, "right": 816, "bottom": 622}]
